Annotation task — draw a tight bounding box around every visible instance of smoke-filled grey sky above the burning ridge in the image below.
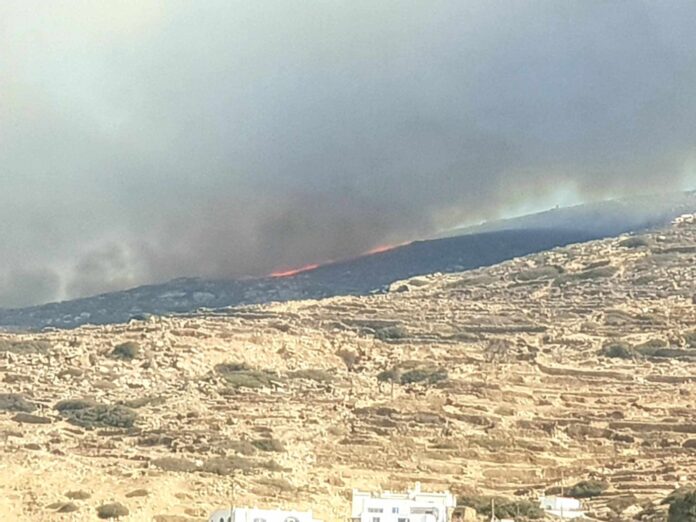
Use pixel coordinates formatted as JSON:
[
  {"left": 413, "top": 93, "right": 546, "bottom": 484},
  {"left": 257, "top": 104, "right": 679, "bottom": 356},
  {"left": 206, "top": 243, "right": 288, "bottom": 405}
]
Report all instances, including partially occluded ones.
[{"left": 0, "top": 0, "right": 696, "bottom": 307}]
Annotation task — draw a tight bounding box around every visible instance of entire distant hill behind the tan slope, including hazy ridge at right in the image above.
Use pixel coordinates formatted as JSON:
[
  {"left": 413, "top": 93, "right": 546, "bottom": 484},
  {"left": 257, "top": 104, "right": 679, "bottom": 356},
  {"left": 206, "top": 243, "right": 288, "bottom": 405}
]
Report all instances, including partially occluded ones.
[{"left": 0, "top": 192, "right": 696, "bottom": 329}]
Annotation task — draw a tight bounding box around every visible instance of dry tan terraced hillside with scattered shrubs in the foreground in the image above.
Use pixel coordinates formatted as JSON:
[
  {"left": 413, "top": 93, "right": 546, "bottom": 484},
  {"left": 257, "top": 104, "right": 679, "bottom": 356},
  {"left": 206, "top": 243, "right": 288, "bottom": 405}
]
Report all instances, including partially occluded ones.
[{"left": 0, "top": 213, "right": 696, "bottom": 522}]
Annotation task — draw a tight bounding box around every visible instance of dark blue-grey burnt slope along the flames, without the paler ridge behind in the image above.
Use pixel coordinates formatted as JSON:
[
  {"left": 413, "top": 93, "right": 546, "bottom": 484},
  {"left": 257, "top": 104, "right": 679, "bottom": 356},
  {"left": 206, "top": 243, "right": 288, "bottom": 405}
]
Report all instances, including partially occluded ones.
[{"left": 0, "top": 225, "right": 594, "bottom": 329}]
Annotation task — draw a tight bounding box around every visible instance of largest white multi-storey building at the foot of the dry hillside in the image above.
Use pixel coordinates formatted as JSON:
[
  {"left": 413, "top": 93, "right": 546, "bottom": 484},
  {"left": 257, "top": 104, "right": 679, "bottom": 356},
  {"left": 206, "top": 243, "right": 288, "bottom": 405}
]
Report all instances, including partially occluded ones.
[{"left": 351, "top": 484, "right": 457, "bottom": 522}]
